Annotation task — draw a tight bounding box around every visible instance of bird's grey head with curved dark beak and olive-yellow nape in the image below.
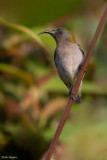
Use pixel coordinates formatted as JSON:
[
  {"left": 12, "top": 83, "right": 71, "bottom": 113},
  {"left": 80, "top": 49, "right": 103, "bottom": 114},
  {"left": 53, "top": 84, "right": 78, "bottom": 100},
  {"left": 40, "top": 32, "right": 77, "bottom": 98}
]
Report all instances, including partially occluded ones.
[{"left": 39, "top": 27, "right": 76, "bottom": 43}]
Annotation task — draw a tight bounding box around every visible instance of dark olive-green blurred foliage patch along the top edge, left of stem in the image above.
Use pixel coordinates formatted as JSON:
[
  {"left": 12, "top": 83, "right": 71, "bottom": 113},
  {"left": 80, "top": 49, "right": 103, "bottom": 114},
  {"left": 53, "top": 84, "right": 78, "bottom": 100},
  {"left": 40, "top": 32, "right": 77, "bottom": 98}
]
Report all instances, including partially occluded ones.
[{"left": 0, "top": 0, "right": 82, "bottom": 26}]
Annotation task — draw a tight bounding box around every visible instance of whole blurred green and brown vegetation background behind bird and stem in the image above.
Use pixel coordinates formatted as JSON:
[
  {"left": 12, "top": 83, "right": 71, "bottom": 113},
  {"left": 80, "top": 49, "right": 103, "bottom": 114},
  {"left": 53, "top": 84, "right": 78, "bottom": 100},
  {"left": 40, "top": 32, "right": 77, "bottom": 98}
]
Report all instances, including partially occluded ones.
[{"left": 0, "top": 0, "right": 107, "bottom": 160}]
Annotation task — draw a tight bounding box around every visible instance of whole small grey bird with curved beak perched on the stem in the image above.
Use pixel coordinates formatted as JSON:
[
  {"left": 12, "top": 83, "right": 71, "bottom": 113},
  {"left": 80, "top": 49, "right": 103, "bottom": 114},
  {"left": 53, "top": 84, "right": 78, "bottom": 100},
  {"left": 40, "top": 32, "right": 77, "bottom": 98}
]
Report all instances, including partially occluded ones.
[{"left": 39, "top": 27, "right": 85, "bottom": 103}]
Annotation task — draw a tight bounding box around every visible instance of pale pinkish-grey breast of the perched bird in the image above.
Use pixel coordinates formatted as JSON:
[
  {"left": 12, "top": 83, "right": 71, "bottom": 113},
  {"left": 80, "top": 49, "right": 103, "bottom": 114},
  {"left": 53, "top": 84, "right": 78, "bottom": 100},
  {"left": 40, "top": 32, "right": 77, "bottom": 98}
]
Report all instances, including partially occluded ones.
[{"left": 55, "top": 43, "right": 83, "bottom": 79}]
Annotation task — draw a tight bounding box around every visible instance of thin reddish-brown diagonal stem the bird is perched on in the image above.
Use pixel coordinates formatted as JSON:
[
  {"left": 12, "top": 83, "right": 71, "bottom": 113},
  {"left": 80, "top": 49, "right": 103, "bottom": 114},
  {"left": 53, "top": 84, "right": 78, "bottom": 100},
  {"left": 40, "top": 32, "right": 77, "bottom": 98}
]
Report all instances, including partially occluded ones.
[{"left": 45, "top": 8, "right": 107, "bottom": 160}]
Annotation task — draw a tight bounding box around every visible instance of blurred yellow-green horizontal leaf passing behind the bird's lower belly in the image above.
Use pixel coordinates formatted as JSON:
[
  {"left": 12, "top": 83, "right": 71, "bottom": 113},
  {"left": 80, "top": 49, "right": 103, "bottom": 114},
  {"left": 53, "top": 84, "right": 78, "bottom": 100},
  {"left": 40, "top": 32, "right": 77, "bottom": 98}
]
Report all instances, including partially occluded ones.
[{"left": 40, "top": 76, "right": 107, "bottom": 95}]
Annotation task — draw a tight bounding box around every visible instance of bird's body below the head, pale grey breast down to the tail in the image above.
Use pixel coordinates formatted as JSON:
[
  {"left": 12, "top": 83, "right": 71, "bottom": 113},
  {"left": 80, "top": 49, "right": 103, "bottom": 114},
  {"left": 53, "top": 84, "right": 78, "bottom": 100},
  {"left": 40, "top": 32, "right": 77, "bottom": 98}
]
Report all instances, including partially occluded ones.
[{"left": 54, "top": 41, "right": 84, "bottom": 103}]
